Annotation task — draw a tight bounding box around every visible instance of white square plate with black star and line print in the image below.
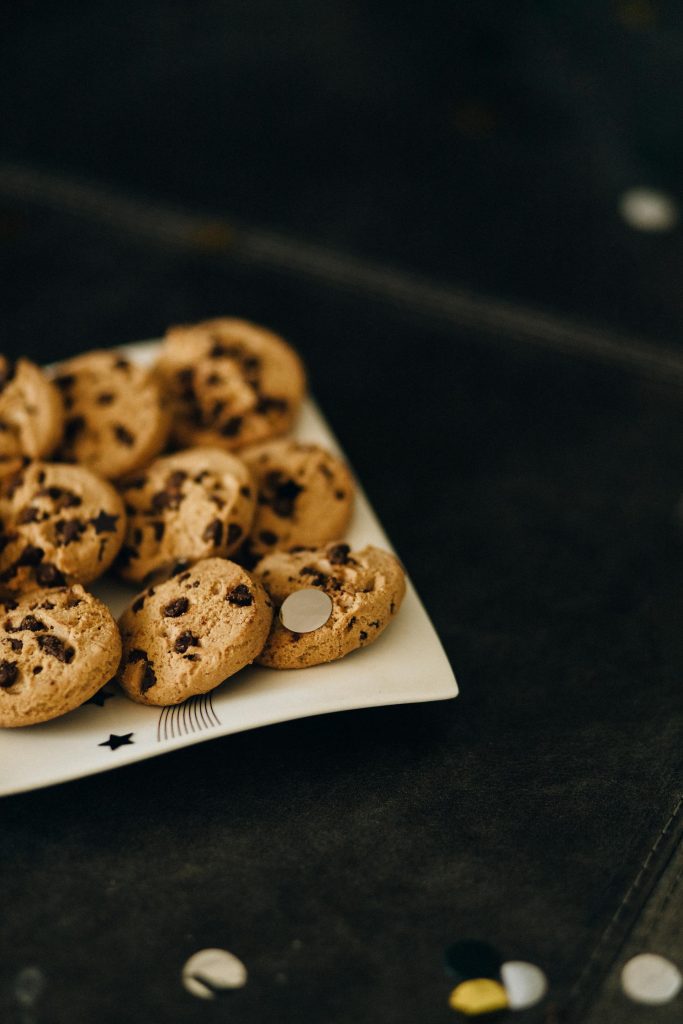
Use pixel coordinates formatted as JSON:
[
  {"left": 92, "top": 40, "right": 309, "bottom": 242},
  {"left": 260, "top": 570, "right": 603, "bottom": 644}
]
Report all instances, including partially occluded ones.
[{"left": 0, "top": 342, "right": 458, "bottom": 796}]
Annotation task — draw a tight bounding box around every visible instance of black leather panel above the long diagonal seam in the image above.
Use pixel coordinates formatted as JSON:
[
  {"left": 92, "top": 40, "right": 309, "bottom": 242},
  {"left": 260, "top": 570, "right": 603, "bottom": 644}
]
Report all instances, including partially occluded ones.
[{"left": 0, "top": 0, "right": 683, "bottom": 343}]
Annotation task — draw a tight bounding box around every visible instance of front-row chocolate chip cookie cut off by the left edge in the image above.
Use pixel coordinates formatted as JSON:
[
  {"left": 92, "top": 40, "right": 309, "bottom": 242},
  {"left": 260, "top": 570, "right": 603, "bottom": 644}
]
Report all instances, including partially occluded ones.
[{"left": 0, "top": 585, "right": 121, "bottom": 728}]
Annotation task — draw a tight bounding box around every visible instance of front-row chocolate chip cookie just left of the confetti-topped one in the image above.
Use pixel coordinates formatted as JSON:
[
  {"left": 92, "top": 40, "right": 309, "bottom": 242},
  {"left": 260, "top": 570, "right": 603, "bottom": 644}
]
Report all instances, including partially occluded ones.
[{"left": 119, "top": 558, "right": 272, "bottom": 705}]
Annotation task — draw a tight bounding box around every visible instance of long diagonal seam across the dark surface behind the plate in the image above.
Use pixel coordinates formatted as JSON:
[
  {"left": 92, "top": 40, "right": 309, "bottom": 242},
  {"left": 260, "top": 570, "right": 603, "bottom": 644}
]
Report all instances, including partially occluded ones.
[{"left": 0, "top": 161, "right": 683, "bottom": 384}]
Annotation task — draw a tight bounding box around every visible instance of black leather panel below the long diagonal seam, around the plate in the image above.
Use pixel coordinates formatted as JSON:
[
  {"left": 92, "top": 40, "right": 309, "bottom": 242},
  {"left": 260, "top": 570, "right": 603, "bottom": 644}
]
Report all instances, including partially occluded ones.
[{"left": 0, "top": 209, "right": 683, "bottom": 1024}]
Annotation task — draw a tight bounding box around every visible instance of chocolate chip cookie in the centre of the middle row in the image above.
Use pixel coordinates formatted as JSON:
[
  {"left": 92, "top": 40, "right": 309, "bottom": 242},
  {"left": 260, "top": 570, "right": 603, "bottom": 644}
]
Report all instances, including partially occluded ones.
[{"left": 118, "top": 447, "right": 254, "bottom": 583}]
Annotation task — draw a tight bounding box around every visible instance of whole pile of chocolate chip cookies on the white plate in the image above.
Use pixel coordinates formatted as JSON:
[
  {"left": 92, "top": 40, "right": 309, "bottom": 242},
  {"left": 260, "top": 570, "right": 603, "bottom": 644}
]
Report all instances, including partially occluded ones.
[{"left": 0, "top": 318, "right": 405, "bottom": 726}]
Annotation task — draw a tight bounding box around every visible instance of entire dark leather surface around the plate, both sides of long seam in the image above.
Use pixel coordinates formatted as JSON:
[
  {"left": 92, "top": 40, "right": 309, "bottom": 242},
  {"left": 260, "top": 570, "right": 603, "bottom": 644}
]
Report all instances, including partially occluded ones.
[{"left": 0, "top": 2, "right": 683, "bottom": 1024}]
